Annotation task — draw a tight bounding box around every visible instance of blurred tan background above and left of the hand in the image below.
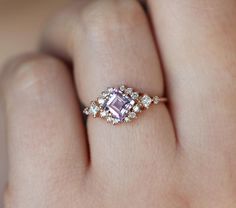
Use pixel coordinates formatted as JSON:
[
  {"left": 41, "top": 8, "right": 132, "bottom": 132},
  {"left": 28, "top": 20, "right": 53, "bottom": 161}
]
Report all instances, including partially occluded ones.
[{"left": 0, "top": 0, "right": 69, "bottom": 208}]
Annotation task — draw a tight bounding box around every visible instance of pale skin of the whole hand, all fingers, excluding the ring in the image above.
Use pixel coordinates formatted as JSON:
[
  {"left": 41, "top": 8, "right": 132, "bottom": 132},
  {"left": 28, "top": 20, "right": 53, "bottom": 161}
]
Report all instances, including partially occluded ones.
[{"left": 0, "top": 0, "right": 236, "bottom": 208}]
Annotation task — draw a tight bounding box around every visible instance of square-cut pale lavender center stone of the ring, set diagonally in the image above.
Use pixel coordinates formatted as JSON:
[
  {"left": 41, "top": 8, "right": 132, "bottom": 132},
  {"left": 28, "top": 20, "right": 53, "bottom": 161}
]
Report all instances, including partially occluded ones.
[{"left": 106, "top": 90, "right": 134, "bottom": 121}]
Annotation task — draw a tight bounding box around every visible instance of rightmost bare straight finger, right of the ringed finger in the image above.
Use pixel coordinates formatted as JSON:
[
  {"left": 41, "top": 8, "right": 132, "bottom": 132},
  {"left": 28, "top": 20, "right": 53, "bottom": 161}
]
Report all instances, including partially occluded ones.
[{"left": 148, "top": 0, "right": 236, "bottom": 154}]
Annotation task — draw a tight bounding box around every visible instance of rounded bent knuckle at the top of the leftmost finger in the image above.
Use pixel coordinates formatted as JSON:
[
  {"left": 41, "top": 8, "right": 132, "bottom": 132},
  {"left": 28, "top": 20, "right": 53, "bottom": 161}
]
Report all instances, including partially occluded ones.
[{"left": 1, "top": 54, "right": 65, "bottom": 93}]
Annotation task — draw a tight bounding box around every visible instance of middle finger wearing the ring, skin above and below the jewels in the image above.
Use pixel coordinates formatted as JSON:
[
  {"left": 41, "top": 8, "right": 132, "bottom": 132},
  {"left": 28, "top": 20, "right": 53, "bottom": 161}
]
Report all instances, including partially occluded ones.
[{"left": 42, "top": 0, "right": 175, "bottom": 182}]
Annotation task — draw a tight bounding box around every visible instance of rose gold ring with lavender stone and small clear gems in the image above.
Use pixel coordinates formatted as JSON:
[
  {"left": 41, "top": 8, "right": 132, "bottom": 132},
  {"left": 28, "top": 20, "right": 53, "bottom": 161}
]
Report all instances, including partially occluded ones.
[{"left": 83, "top": 85, "right": 167, "bottom": 125}]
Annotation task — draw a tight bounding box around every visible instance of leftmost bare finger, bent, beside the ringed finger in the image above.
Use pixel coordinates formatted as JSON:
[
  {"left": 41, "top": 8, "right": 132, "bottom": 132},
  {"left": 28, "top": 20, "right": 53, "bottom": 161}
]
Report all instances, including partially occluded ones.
[{"left": 0, "top": 54, "right": 88, "bottom": 207}]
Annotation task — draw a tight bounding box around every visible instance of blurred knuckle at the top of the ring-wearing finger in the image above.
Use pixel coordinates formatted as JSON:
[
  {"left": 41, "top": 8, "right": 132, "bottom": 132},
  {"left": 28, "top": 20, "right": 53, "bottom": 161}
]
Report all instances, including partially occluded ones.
[{"left": 75, "top": 0, "right": 146, "bottom": 41}]
